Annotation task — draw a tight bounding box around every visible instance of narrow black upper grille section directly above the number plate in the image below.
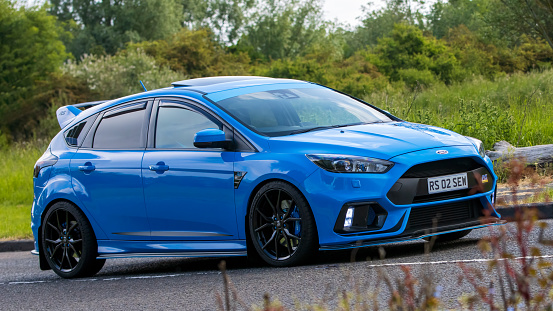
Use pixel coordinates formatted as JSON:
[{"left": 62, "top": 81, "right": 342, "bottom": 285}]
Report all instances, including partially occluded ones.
[{"left": 401, "top": 158, "right": 482, "bottom": 178}]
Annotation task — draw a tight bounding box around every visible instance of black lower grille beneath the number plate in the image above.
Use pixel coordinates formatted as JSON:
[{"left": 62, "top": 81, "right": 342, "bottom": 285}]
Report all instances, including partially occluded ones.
[{"left": 405, "top": 200, "right": 483, "bottom": 232}]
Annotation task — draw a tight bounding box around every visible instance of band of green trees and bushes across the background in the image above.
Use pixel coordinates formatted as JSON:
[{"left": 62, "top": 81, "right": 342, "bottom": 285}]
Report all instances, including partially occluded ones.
[{"left": 0, "top": 0, "right": 553, "bottom": 139}]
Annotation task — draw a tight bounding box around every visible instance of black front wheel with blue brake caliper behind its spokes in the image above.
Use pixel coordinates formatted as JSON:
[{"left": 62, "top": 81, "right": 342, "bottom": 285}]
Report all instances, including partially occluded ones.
[{"left": 248, "top": 181, "right": 318, "bottom": 267}]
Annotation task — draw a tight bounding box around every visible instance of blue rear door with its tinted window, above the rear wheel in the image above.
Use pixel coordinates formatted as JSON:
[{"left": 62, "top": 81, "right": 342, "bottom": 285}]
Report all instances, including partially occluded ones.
[{"left": 70, "top": 101, "right": 153, "bottom": 240}]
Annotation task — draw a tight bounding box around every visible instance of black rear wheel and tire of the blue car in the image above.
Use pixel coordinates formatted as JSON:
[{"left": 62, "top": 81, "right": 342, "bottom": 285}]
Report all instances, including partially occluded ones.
[{"left": 41, "top": 202, "right": 106, "bottom": 279}]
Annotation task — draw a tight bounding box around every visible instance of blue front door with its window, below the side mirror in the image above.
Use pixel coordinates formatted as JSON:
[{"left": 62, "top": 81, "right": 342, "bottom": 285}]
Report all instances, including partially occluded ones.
[{"left": 142, "top": 99, "right": 237, "bottom": 241}]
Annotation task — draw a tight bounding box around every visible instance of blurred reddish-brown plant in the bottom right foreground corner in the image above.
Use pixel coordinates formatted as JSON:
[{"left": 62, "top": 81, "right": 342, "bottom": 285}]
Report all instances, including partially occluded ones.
[{"left": 459, "top": 165, "right": 553, "bottom": 311}]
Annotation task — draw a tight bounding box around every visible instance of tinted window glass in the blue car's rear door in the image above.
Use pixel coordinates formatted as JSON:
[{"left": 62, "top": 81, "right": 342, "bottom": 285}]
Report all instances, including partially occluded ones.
[{"left": 92, "top": 109, "right": 146, "bottom": 149}]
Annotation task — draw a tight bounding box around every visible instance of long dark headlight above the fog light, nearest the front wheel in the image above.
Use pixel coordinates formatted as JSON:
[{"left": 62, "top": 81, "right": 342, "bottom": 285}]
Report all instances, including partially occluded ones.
[{"left": 306, "top": 154, "right": 394, "bottom": 174}]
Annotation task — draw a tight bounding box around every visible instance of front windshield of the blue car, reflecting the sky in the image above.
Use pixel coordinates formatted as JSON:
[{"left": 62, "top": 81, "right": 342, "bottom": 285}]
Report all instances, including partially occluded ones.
[{"left": 212, "top": 88, "right": 392, "bottom": 136}]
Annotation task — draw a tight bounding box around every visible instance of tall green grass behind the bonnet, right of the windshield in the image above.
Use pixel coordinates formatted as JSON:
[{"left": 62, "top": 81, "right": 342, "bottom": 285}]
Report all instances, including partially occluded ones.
[{"left": 364, "top": 70, "right": 553, "bottom": 149}]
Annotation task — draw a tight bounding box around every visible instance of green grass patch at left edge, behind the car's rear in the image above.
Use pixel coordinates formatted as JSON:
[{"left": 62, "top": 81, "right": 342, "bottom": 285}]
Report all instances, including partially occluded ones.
[{"left": 0, "top": 141, "right": 46, "bottom": 240}]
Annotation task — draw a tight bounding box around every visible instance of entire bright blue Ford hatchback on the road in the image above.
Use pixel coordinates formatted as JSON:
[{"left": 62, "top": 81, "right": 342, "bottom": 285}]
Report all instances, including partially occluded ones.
[{"left": 32, "top": 77, "right": 501, "bottom": 278}]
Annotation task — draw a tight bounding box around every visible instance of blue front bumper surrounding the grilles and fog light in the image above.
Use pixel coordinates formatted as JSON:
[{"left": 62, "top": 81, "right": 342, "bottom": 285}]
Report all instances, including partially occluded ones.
[{"left": 304, "top": 146, "right": 501, "bottom": 249}]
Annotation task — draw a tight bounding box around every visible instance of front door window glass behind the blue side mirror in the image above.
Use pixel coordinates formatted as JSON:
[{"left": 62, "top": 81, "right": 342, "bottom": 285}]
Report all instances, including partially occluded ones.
[{"left": 155, "top": 106, "right": 221, "bottom": 149}]
